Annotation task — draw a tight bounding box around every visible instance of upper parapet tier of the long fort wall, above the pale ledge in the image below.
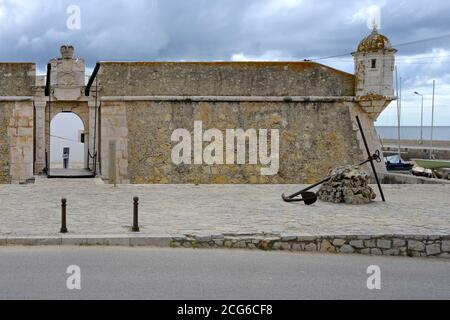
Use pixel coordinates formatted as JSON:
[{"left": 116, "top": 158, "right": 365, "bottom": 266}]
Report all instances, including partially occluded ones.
[{"left": 99, "top": 62, "right": 355, "bottom": 96}]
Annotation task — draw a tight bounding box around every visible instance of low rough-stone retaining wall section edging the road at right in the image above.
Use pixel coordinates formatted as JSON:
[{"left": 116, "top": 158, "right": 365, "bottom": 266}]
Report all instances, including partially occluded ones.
[{"left": 170, "top": 234, "right": 450, "bottom": 259}]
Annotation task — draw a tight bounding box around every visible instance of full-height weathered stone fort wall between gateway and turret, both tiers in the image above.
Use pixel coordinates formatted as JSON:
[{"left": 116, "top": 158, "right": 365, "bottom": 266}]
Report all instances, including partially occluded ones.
[{"left": 98, "top": 62, "right": 373, "bottom": 184}]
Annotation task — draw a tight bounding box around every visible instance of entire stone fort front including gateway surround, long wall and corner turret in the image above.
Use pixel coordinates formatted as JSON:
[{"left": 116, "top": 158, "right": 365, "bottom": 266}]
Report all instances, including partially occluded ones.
[{"left": 0, "top": 30, "right": 396, "bottom": 184}]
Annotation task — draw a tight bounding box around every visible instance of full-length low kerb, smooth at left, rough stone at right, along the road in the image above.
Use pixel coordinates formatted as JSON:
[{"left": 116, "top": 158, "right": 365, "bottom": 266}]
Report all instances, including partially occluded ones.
[{"left": 0, "top": 234, "right": 450, "bottom": 259}]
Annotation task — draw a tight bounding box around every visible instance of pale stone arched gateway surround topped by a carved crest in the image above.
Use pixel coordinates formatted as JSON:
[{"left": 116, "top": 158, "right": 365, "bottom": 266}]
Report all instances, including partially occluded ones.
[{"left": 34, "top": 46, "right": 98, "bottom": 177}]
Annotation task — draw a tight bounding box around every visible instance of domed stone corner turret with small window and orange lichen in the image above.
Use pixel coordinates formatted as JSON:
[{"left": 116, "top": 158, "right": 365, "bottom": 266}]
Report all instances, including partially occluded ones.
[{"left": 353, "top": 28, "right": 397, "bottom": 120}]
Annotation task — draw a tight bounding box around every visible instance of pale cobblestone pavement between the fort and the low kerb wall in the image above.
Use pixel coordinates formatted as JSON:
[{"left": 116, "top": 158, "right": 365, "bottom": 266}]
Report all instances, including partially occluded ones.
[{"left": 0, "top": 178, "right": 450, "bottom": 236}]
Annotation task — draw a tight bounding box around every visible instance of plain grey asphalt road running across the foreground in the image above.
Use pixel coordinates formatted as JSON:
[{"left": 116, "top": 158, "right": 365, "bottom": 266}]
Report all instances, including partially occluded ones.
[{"left": 0, "top": 247, "right": 450, "bottom": 300}]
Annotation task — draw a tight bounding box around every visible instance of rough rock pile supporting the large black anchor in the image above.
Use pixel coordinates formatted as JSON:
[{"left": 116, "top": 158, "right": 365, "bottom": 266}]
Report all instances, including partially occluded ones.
[{"left": 318, "top": 166, "right": 376, "bottom": 204}]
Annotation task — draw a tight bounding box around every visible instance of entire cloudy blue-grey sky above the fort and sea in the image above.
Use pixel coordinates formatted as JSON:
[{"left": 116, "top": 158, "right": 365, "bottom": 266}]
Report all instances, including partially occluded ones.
[{"left": 0, "top": 0, "right": 450, "bottom": 130}]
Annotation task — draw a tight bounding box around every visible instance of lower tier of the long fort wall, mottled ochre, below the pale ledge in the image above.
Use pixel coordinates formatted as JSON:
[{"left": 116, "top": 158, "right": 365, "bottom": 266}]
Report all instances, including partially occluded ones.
[{"left": 102, "top": 101, "right": 362, "bottom": 184}]
